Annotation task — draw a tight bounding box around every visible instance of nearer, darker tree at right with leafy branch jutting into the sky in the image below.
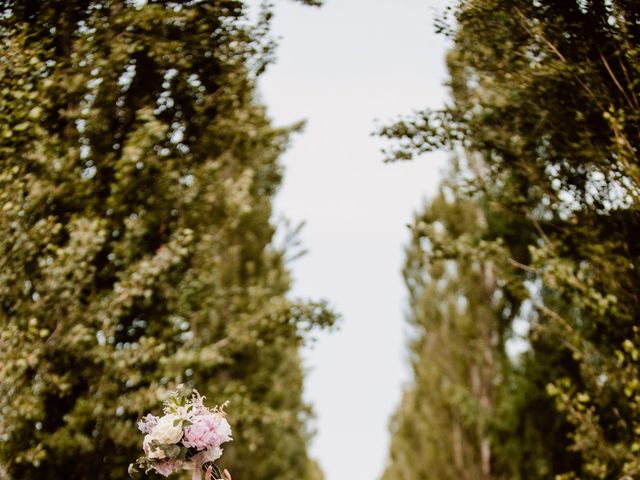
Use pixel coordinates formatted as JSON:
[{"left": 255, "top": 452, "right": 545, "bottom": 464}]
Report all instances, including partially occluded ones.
[{"left": 380, "top": 0, "right": 640, "bottom": 479}]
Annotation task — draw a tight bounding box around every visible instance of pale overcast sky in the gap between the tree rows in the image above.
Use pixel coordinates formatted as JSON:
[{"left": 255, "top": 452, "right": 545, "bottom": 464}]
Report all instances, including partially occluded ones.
[{"left": 249, "top": 0, "right": 447, "bottom": 480}]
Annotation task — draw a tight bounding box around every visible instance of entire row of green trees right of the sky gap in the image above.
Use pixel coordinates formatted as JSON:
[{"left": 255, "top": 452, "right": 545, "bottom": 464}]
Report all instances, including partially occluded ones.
[{"left": 381, "top": 0, "right": 640, "bottom": 480}]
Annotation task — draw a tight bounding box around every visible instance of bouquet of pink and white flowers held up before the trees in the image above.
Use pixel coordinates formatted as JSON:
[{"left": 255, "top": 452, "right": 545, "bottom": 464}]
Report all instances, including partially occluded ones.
[{"left": 129, "top": 385, "right": 232, "bottom": 480}]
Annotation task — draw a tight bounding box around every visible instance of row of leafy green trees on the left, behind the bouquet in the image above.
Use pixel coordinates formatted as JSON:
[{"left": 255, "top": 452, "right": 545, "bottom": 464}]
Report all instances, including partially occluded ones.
[{"left": 0, "top": 0, "right": 334, "bottom": 480}]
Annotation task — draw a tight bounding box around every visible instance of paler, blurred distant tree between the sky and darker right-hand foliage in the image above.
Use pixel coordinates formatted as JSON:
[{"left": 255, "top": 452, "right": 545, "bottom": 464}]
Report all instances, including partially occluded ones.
[{"left": 382, "top": 168, "right": 505, "bottom": 480}]
